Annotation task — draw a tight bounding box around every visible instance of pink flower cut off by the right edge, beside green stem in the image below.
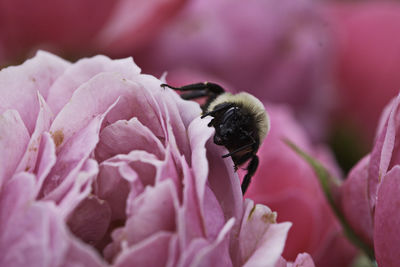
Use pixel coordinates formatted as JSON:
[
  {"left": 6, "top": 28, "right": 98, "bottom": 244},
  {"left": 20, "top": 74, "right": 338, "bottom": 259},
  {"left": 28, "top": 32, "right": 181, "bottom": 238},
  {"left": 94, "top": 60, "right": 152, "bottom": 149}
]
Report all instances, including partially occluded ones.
[{"left": 341, "top": 95, "right": 400, "bottom": 266}]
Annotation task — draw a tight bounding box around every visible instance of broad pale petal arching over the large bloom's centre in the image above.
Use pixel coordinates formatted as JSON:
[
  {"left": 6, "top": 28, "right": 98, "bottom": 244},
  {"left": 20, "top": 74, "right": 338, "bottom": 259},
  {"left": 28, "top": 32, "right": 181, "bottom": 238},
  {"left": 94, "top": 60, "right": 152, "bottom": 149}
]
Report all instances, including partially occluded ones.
[{"left": 50, "top": 73, "right": 164, "bottom": 147}]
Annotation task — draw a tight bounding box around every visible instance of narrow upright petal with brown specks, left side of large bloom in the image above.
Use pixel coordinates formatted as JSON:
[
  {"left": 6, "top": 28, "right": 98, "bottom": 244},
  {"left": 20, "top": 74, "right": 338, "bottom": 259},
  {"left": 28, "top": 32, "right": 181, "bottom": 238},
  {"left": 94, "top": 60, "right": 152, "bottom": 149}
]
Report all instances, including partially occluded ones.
[{"left": 16, "top": 92, "right": 53, "bottom": 175}]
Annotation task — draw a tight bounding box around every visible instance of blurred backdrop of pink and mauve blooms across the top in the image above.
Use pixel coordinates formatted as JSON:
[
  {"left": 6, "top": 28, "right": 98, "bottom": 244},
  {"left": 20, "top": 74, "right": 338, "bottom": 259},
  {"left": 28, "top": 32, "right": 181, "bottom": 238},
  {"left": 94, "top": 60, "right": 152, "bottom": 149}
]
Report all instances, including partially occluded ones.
[{"left": 0, "top": 0, "right": 400, "bottom": 266}]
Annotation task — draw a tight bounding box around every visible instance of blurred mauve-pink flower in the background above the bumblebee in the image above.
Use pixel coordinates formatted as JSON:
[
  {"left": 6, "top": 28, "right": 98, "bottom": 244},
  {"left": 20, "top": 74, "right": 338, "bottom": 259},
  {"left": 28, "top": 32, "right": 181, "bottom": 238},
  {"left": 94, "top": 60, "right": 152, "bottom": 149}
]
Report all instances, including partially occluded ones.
[{"left": 136, "top": 0, "right": 332, "bottom": 142}]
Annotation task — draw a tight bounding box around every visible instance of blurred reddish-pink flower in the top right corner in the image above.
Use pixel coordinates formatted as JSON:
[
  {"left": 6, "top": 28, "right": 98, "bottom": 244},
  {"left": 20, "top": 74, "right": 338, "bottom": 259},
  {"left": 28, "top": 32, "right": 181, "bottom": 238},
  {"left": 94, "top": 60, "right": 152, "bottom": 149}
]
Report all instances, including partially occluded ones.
[{"left": 325, "top": 1, "right": 400, "bottom": 147}]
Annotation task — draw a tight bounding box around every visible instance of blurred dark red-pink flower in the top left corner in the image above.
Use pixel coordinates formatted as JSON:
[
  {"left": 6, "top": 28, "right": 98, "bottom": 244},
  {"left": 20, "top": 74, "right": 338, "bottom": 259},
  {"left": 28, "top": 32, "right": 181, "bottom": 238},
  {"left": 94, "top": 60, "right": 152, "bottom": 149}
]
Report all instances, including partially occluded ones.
[{"left": 0, "top": 0, "right": 185, "bottom": 66}]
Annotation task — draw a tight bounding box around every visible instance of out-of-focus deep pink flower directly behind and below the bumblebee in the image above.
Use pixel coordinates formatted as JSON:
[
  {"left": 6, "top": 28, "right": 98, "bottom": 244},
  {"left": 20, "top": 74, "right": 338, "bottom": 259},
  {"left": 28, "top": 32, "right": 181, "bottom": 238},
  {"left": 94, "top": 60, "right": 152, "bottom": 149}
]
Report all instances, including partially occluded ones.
[{"left": 245, "top": 104, "right": 356, "bottom": 266}]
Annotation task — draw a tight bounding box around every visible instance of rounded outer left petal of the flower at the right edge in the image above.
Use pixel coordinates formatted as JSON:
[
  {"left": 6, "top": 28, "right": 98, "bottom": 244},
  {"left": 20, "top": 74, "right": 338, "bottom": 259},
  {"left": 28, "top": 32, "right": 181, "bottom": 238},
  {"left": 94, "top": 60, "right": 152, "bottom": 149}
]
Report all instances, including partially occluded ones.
[{"left": 341, "top": 156, "right": 373, "bottom": 245}]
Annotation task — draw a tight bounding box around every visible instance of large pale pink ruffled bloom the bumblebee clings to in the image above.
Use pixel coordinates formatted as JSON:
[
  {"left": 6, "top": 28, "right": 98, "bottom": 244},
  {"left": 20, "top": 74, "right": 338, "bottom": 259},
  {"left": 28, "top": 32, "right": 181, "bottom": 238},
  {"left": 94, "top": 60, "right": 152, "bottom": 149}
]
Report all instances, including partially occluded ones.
[{"left": 0, "top": 52, "right": 298, "bottom": 266}]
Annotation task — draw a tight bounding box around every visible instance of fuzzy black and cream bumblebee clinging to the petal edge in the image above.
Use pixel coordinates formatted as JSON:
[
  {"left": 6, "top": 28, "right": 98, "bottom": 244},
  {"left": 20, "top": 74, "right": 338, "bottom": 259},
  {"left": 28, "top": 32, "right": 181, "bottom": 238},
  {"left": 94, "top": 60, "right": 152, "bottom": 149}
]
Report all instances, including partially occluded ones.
[{"left": 161, "top": 82, "right": 270, "bottom": 195}]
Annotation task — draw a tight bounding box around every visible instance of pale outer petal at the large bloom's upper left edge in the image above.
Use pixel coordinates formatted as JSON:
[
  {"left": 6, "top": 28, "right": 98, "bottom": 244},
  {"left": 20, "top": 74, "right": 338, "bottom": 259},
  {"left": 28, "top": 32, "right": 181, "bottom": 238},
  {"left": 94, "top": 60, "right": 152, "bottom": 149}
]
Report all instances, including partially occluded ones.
[{"left": 0, "top": 52, "right": 69, "bottom": 133}]
